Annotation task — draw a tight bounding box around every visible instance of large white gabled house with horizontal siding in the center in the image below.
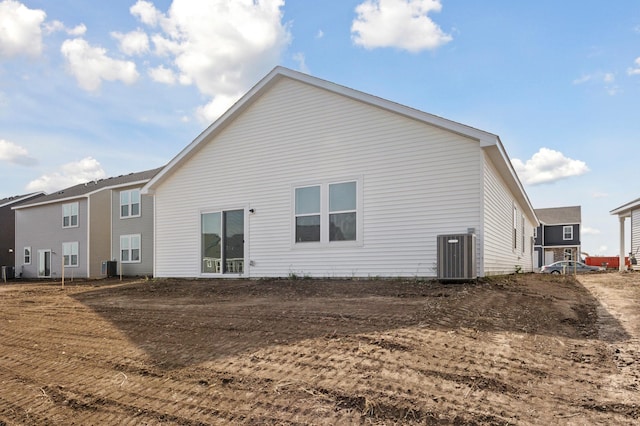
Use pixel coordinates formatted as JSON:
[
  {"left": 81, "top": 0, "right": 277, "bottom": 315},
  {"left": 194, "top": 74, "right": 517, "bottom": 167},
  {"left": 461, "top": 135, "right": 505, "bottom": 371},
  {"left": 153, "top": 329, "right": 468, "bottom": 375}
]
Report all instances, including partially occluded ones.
[{"left": 142, "top": 67, "right": 538, "bottom": 277}]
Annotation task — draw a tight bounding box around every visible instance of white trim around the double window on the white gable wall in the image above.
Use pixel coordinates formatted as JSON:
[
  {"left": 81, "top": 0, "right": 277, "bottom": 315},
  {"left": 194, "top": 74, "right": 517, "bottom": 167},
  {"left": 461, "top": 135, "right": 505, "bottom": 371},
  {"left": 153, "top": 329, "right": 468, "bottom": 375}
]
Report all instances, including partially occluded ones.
[{"left": 290, "top": 176, "right": 364, "bottom": 250}]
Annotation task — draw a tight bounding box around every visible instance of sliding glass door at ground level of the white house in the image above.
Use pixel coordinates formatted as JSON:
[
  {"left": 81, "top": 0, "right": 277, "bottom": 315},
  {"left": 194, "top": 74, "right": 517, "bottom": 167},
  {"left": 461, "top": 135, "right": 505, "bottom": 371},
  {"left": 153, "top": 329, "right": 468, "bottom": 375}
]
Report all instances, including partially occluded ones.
[{"left": 200, "top": 210, "right": 244, "bottom": 274}]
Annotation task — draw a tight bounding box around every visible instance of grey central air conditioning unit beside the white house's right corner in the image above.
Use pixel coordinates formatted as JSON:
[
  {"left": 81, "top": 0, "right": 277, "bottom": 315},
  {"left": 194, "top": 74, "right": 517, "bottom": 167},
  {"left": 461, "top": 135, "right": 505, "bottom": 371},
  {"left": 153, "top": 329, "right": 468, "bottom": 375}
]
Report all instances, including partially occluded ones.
[{"left": 438, "top": 234, "right": 478, "bottom": 281}]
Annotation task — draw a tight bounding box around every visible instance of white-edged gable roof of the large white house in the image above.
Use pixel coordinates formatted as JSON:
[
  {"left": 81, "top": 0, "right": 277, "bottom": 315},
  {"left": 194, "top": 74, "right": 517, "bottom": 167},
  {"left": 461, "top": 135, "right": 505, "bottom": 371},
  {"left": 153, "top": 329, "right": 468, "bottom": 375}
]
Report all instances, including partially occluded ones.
[{"left": 142, "top": 66, "right": 538, "bottom": 224}]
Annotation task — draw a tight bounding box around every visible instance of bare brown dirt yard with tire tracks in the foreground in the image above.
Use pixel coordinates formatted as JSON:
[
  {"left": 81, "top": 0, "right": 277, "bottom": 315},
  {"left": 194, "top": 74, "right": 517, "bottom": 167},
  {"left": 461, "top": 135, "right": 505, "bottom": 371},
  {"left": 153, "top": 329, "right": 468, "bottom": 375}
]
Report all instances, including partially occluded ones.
[{"left": 0, "top": 273, "right": 640, "bottom": 425}]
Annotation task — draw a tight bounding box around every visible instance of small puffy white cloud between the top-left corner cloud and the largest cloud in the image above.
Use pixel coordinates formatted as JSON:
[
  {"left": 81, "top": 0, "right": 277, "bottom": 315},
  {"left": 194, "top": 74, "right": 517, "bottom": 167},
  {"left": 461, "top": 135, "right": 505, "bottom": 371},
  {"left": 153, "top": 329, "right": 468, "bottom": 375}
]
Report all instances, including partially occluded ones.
[{"left": 60, "top": 38, "right": 138, "bottom": 91}]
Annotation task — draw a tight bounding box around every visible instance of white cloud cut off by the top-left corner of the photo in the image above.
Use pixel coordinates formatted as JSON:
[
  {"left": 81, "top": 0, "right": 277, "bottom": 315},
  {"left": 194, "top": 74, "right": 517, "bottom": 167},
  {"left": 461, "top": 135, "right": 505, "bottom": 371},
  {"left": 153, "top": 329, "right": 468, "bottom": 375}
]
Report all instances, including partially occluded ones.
[{"left": 0, "top": 0, "right": 47, "bottom": 58}]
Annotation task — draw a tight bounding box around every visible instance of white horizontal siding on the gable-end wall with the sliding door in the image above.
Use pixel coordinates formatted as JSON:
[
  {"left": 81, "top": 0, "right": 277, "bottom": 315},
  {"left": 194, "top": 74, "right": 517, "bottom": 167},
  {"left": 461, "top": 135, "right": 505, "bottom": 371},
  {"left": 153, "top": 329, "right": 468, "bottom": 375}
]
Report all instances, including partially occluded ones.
[{"left": 155, "top": 79, "right": 482, "bottom": 277}]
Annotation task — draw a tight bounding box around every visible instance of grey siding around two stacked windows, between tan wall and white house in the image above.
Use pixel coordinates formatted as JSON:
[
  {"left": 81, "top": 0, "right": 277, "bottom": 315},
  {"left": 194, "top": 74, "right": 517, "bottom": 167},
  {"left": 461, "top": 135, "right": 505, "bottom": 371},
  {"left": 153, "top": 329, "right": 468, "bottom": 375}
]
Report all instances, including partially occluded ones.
[{"left": 109, "top": 186, "right": 153, "bottom": 276}]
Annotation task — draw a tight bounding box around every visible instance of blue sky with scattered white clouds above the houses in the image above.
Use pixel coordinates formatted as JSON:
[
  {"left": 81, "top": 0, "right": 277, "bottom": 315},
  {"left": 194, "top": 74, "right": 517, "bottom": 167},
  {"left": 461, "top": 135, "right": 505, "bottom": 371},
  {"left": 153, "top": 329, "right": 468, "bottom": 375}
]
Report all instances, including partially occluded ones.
[{"left": 0, "top": 0, "right": 640, "bottom": 255}]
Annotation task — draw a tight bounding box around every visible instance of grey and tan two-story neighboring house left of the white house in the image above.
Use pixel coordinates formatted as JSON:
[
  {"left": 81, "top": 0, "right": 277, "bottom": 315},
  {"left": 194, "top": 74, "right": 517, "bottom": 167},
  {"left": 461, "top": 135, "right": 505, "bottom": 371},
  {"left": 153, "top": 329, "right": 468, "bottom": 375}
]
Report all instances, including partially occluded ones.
[{"left": 14, "top": 169, "right": 160, "bottom": 278}]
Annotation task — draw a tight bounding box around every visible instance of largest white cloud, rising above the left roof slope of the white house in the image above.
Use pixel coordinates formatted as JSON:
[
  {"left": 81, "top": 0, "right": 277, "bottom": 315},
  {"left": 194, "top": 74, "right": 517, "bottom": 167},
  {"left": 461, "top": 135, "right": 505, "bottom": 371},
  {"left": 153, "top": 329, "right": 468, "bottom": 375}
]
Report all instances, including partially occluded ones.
[{"left": 130, "top": 0, "right": 291, "bottom": 121}]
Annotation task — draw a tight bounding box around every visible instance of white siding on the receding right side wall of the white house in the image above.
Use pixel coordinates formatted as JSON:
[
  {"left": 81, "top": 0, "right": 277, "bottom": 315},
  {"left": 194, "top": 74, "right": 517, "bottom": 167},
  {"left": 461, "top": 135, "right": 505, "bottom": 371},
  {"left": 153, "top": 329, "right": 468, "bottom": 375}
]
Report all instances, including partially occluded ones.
[{"left": 482, "top": 151, "right": 535, "bottom": 275}]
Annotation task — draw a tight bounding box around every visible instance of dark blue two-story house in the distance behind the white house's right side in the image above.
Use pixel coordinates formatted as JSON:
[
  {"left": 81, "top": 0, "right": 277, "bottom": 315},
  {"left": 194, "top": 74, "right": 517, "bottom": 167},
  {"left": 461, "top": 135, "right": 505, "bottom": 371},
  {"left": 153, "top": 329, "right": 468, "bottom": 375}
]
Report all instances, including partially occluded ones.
[{"left": 534, "top": 206, "right": 582, "bottom": 268}]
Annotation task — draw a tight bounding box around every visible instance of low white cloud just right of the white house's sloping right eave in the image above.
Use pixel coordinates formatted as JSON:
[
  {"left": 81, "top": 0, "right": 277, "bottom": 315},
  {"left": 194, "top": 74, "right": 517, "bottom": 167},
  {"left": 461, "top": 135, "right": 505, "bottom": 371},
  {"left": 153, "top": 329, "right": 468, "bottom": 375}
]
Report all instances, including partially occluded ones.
[{"left": 511, "top": 148, "right": 589, "bottom": 185}]
